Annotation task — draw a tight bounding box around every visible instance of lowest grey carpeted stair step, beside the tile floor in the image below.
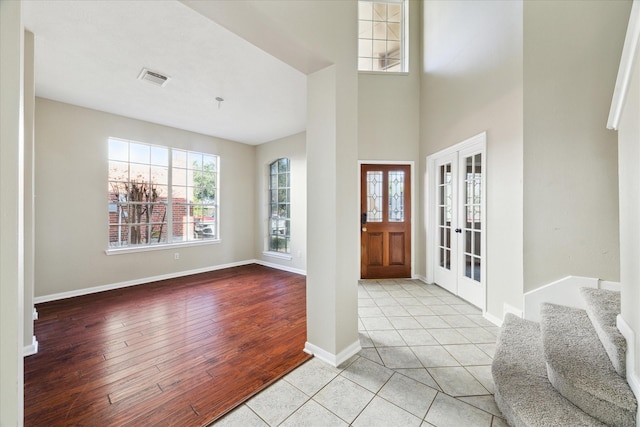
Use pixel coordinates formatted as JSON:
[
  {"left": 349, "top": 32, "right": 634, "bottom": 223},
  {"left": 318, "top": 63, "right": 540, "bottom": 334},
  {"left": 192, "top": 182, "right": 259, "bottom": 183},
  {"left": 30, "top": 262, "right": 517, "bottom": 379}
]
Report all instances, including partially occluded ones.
[{"left": 491, "top": 313, "right": 604, "bottom": 427}]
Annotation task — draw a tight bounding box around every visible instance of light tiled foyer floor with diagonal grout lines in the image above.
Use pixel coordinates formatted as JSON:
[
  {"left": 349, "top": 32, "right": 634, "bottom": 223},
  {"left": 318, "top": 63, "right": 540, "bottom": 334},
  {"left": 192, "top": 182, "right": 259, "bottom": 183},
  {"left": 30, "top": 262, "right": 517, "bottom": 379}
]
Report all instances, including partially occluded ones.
[{"left": 216, "top": 280, "right": 507, "bottom": 427}]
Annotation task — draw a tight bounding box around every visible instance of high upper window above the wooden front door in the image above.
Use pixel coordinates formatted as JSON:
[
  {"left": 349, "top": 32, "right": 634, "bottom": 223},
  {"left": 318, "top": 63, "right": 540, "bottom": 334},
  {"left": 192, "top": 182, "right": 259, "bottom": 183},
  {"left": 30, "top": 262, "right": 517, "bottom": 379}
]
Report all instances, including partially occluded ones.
[{"left": 358, "top": 0, "right": 409, "bottom": 73}]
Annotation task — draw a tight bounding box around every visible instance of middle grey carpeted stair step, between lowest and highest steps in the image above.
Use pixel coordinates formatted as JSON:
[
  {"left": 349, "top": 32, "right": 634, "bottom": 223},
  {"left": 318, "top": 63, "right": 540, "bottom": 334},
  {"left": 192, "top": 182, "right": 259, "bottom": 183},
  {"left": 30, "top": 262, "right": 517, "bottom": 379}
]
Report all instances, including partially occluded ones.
[{"left": 540, "top": 303, "right": 637, "bottom": 427}]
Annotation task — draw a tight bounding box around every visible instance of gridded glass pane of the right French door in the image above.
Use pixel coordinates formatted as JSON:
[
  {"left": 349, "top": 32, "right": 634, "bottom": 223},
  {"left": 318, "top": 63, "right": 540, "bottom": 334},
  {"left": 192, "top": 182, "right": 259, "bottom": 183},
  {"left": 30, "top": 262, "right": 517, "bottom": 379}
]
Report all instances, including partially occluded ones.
[{"left": 462, "top": 153, "right": 482, "bottom": 282}]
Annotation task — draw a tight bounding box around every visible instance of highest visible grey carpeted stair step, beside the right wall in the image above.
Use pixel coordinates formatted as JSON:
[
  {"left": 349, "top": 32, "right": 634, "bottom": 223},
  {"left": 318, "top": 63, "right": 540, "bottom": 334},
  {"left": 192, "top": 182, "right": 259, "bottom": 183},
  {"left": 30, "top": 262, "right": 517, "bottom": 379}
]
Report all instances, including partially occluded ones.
[{"left": 580, "top": 288, "right": 627, "bottom": 378}]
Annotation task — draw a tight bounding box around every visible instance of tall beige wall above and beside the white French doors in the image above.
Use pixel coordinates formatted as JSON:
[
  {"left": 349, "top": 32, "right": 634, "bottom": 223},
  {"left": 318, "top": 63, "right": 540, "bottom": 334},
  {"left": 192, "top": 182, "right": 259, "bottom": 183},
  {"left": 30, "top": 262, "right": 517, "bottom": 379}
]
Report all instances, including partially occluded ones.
[{"left": 418, "top": 1, "right": 523, "bottom": 319}]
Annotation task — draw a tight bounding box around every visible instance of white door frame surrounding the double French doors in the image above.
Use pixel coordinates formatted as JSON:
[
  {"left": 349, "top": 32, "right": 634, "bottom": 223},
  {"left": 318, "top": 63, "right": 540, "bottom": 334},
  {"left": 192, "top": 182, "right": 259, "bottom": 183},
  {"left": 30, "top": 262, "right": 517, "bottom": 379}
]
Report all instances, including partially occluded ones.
[{"left": 424, "top": 131, "right": 488, "bottom": 313}]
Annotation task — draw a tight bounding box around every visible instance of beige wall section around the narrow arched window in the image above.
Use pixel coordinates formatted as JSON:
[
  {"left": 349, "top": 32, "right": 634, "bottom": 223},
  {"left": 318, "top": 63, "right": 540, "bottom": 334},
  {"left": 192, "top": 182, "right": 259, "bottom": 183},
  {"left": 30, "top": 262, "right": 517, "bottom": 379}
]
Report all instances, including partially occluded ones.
[{"left": 255, "top": 132, "right": 307, "bottom": 272}]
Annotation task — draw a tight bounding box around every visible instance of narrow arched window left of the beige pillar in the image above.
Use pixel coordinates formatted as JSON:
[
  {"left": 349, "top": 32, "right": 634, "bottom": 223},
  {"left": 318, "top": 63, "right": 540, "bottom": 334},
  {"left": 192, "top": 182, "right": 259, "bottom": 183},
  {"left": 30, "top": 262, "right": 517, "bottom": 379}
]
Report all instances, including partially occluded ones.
[{"left": 269, "top": 158, "right": 291, "bottom": 254}]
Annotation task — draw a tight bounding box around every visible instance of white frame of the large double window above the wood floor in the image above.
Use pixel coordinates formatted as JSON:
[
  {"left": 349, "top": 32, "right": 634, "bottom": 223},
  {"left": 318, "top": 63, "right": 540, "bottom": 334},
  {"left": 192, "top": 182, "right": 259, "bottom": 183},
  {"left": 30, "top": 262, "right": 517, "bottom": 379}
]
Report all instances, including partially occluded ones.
[{"left": 105, "top": 137, "right": 221, "bottom": 255}]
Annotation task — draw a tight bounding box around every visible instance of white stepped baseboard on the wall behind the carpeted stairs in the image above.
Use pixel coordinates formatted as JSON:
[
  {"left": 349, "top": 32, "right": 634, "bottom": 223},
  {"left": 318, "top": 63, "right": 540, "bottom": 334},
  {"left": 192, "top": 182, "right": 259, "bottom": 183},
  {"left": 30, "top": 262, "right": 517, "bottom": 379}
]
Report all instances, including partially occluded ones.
[{"left": 524, "top": 276, "right": 620, "bottom": 322}]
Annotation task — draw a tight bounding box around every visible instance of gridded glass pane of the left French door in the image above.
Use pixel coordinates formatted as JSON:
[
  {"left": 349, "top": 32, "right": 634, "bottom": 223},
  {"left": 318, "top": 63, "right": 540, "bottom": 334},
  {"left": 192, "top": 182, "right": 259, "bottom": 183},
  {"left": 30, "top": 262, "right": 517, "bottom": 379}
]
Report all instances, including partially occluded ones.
[{"left": 436, "top": 163, "right": 453, "bottom": 270}]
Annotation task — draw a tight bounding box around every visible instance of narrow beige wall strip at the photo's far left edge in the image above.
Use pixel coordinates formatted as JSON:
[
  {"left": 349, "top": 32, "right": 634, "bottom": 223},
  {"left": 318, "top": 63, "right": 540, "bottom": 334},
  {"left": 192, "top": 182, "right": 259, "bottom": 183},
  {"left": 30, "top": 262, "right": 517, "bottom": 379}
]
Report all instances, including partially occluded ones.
[{"left": 0, "top": 1, "right": 24, "bottom": 426}]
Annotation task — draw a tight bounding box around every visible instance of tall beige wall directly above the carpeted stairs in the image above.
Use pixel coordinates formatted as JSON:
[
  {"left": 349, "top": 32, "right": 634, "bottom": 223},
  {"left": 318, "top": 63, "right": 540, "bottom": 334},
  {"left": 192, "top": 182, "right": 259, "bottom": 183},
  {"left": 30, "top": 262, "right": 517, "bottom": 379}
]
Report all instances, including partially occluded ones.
[{"left": 524, "top": 1, "right": 631, "bottom": 292}]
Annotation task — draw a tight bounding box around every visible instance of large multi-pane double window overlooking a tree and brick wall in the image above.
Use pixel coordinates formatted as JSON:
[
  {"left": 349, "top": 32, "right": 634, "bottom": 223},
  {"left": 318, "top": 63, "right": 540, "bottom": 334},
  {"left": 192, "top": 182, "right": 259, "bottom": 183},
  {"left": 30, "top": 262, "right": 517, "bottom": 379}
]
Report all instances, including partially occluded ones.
[{"left": 108, "top": 137, "right": 220, "bottom": 251}]
